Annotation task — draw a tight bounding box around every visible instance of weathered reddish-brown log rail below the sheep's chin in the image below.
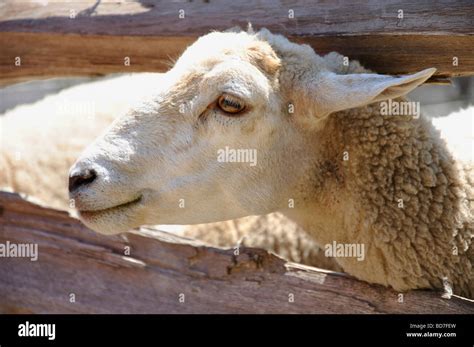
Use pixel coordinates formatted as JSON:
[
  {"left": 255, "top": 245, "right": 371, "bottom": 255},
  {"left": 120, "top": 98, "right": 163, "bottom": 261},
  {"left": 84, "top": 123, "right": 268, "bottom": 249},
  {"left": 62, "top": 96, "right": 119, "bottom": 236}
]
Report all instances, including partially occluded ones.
[{"left": 0, "top": 192, "right": 474, "bottom": 313}]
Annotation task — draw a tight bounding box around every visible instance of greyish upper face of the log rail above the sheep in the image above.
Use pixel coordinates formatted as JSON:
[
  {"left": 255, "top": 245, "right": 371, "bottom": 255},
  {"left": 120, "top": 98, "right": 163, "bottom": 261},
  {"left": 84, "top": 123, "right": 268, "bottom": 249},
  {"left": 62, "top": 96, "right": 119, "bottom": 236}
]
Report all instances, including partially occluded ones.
[{"left": 0, "top": 0, "right": 474, "bottom": 36}]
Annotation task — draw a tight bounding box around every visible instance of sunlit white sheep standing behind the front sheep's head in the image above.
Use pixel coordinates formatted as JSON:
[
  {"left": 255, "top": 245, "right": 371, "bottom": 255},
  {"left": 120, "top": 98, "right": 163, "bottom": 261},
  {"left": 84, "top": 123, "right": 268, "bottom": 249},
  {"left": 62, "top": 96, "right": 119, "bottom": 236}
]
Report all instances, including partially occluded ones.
[{"left": 0, "top": 77, "right": 341, "bottom": 271}]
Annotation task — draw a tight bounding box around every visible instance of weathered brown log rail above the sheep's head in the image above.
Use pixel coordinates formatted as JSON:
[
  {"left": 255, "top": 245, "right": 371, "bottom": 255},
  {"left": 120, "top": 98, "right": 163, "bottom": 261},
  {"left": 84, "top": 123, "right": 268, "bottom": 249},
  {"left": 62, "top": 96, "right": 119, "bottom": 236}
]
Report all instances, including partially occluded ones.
[{"left": 0, "top": 0, "right": 474, "bottom": 85}]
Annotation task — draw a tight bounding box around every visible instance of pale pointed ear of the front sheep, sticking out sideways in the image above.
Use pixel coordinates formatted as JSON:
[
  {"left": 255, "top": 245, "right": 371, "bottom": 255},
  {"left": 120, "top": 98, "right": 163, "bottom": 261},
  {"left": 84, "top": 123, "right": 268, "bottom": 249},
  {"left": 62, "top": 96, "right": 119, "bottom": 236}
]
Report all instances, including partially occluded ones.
[{"left": 315, "top": 68, "right": 436, "bottom": 117}]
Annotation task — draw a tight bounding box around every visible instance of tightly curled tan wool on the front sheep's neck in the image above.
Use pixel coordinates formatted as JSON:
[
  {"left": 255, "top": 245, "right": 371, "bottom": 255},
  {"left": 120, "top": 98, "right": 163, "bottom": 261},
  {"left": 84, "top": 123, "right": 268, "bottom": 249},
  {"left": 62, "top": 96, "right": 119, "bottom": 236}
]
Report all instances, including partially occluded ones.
[{"left": 332, "top": 102, "right": 474, "bottom": 296}]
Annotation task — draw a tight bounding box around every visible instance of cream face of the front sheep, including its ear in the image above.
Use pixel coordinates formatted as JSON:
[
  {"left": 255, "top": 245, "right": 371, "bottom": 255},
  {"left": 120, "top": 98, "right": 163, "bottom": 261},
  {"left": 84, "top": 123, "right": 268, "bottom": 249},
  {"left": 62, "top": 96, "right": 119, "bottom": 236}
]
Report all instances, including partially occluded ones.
[{"left": 69, "top": 31, "right": 436, "bottom": 234}]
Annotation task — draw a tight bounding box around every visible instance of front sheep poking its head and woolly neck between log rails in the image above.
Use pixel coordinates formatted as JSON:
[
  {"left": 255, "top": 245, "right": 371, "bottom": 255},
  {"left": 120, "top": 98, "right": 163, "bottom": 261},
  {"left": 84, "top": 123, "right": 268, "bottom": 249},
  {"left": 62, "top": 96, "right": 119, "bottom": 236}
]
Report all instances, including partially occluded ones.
[{"left": 65, "top": 29, "right": 474, "bottom": 297}]
